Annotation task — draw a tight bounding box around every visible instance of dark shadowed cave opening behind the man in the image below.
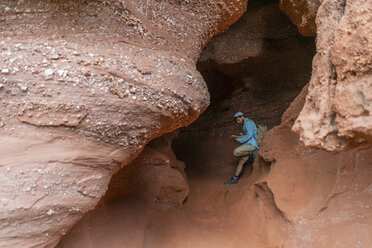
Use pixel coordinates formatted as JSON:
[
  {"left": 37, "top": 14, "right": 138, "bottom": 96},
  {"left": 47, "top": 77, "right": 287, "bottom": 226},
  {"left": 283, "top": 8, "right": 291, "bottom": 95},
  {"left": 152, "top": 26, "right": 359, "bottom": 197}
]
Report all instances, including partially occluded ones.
[{"left": 173, "top": 0, "right": 315, "bottom": 182}]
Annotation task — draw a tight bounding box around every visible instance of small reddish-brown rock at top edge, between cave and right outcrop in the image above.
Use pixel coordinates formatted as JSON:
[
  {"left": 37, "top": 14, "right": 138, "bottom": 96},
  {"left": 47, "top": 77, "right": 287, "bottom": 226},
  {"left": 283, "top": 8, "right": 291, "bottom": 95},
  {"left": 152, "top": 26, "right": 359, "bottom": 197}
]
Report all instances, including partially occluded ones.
[{"left": 280, "top": 0, "right": 321, "bottom": 36}]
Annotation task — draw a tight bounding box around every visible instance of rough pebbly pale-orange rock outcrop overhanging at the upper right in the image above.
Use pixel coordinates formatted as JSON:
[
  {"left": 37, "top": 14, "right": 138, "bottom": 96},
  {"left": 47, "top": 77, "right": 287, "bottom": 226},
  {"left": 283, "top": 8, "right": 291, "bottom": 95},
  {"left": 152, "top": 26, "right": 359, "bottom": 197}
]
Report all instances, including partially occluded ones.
[{"left": 293, "top": 1, "right": 372, "bottom": 150}]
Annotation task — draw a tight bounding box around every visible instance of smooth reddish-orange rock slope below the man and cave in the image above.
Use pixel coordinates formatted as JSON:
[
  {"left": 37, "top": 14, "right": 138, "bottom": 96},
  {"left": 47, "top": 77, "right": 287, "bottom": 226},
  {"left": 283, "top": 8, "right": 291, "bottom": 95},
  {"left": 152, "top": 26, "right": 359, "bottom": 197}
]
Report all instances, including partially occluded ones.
[{"left": 58, "top": 89, "right": 372, "bottom": 248}]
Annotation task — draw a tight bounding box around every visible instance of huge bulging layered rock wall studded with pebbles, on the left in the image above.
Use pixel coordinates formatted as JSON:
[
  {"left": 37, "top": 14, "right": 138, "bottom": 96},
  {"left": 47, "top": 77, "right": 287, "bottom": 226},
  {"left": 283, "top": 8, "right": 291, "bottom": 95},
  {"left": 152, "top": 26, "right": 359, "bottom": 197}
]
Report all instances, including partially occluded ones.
[{"left": 0, "top": 0, "right": 250, "bottom": 247}]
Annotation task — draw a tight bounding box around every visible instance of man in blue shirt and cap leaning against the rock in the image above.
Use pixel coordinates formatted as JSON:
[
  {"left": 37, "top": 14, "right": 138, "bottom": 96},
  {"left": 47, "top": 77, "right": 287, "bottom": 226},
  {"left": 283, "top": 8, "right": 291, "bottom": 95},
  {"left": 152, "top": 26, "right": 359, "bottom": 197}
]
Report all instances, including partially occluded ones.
[{"left": 225, "top": 112, "right": 259, "bottom": 184}]
